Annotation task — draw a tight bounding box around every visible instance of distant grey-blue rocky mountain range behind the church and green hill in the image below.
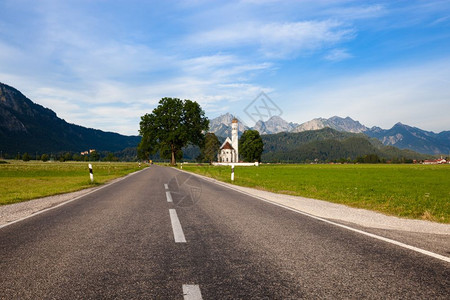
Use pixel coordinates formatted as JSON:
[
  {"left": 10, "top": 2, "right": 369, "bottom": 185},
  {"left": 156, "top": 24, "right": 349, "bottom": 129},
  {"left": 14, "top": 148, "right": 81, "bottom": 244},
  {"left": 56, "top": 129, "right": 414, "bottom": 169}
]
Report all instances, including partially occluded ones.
[{"left": 210, "top": 113, "right": 450, "bottom": 155}]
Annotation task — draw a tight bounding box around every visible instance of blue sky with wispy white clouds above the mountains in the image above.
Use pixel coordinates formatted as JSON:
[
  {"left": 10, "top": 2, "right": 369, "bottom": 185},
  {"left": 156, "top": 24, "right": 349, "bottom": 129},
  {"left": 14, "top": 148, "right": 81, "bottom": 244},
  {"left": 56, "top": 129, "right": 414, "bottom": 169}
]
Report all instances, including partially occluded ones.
[{"left": 0, "top": 0, "right": 450, "bottom": 134}]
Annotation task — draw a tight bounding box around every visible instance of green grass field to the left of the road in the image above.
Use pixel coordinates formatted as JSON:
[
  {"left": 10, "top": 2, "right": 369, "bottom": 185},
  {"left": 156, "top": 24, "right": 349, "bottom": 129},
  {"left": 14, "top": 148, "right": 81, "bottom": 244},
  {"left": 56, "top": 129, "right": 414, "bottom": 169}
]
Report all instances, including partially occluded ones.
[{"left": 0, "top": 161, "right": 145, "bottom": 205}]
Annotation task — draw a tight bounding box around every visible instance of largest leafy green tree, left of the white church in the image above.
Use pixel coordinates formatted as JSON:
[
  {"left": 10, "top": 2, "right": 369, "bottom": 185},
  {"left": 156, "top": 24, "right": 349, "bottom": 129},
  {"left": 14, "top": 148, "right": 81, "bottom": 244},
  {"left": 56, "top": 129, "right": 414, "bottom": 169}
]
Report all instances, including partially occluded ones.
[{"left": 138, "top": 98, "right": 209, "bottom": 165}]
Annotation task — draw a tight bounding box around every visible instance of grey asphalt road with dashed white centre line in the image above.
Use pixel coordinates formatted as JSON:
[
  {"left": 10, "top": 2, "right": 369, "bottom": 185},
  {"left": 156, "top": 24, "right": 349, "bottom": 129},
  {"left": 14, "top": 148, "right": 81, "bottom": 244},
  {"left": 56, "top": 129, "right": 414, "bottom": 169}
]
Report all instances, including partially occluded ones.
[{"left": 0, "top": 166, "right": 450, "bottom": 299}]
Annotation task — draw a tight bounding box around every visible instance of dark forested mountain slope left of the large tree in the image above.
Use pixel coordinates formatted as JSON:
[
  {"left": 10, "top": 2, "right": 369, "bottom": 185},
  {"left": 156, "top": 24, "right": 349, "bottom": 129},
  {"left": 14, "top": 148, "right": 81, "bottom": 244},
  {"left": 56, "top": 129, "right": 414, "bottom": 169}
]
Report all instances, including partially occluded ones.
[{"left": 0, "top": 83, "right": 140, "bottom": 154}]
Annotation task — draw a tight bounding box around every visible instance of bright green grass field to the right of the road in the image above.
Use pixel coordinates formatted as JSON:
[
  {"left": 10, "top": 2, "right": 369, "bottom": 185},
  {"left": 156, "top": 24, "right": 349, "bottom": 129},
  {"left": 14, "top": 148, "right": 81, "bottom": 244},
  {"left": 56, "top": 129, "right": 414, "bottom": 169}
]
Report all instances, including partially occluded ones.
[{"left": 183, "top": 164, "right": 450, "bottom": 223}]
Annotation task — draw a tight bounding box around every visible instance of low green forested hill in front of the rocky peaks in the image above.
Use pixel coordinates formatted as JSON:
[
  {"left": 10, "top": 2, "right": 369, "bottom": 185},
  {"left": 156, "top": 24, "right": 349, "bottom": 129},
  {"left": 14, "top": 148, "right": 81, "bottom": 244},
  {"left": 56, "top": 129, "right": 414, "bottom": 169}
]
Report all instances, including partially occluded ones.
[{"left": 261, "top": 128, "right": 429, "bottom": 162}]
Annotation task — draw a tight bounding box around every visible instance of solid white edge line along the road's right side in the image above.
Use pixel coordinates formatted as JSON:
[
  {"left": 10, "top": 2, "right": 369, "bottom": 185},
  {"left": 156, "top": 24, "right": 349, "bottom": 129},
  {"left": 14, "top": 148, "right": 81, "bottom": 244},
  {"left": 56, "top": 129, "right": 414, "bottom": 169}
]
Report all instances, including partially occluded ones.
[{"left": 178, "top": 170, "right": 450, "bottom": 263}]
